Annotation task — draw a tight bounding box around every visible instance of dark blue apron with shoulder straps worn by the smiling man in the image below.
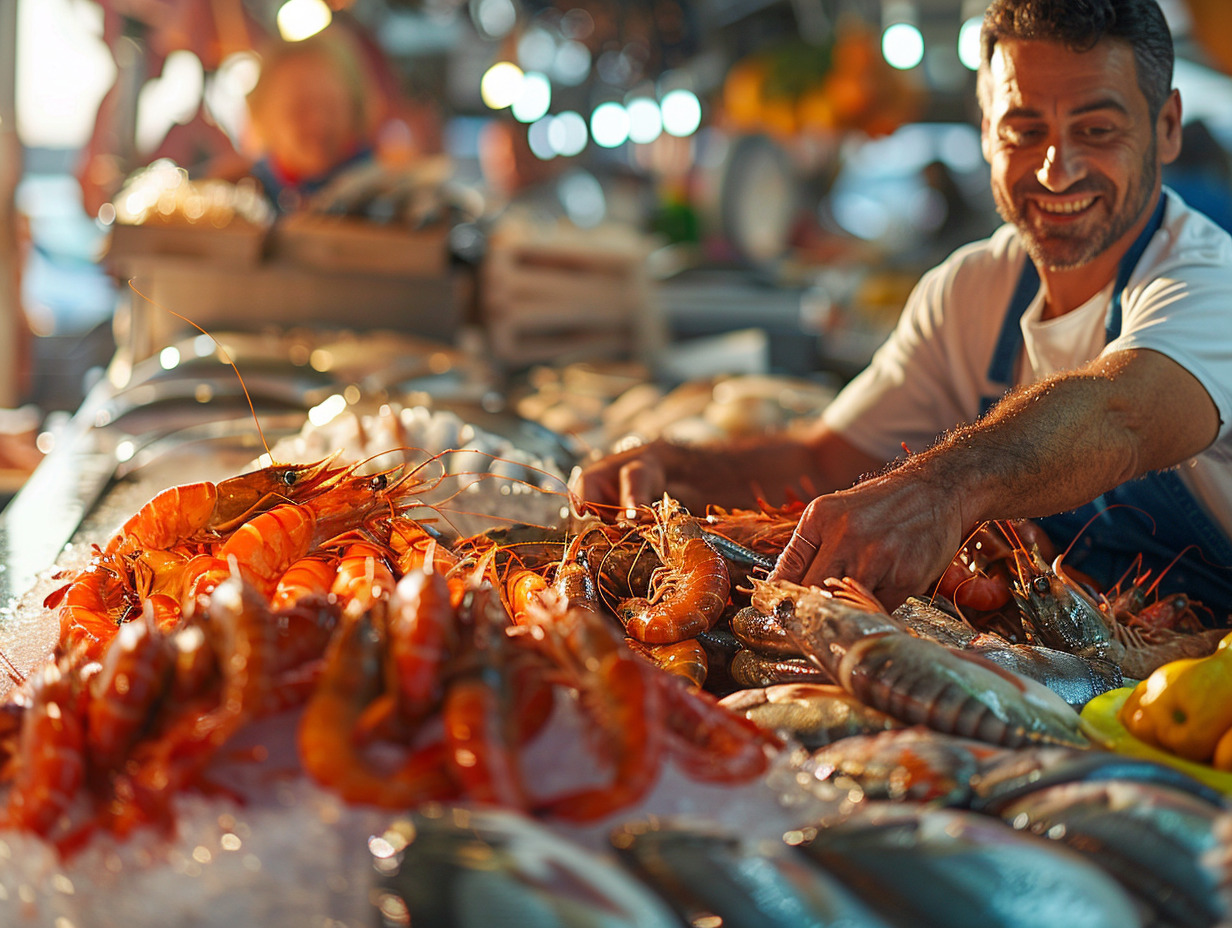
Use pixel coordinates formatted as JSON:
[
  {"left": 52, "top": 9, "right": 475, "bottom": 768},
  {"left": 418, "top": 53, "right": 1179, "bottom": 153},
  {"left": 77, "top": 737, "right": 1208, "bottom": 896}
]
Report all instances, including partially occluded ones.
[{"left": 981, "top": 195, "right": 1232, "bottom": 619}]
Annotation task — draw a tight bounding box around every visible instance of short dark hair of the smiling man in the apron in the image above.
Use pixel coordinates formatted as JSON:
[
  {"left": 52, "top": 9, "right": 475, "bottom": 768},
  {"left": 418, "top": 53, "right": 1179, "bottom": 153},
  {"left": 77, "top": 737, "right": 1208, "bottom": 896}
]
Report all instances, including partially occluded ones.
[{"left": 979, "top": 0, "right": 1174, "bottom": 121}]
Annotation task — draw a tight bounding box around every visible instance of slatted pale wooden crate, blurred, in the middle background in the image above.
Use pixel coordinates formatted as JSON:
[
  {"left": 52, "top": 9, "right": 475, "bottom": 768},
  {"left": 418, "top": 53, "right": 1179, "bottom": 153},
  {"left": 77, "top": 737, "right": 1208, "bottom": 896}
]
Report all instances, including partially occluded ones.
[{"left": 480, "top": 223, "right": 664, "bottom": 366}]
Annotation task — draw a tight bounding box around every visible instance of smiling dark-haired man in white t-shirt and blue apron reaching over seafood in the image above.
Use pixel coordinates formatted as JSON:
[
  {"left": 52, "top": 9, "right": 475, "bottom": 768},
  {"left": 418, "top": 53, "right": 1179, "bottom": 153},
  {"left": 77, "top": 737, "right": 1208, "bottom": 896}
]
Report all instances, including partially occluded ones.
[{"left": 579, "top": 0, "right": 1232, "bottom": 617}]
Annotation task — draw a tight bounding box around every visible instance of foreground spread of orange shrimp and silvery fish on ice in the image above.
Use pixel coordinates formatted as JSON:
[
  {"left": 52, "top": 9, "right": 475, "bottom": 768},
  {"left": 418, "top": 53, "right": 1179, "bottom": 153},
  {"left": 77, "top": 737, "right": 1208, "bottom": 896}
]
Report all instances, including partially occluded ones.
[{"left": 0, "top": 391, "right": 1232, "bottom": 928}]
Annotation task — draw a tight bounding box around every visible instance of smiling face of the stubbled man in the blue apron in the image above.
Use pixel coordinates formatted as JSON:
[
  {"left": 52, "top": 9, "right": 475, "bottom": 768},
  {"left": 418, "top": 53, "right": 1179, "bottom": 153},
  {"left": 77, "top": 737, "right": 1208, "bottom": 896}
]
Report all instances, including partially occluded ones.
[{"left": 982, "top": 39, "right": 1180, "bottom": 270}]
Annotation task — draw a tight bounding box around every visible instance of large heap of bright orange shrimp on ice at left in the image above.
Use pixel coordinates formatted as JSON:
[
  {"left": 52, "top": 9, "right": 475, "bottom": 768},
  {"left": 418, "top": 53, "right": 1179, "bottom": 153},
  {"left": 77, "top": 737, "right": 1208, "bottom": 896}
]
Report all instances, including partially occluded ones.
[{"left": 0, "top": 460, "right": 780, "bottom": 854}]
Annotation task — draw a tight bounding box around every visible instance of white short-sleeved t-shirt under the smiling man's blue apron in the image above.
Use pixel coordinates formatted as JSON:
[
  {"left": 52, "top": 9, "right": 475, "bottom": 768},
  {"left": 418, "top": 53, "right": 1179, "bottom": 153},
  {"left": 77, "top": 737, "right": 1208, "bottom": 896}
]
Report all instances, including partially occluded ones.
[{"left": 824, "top": 191, "right": 1232, "bottom": 536}]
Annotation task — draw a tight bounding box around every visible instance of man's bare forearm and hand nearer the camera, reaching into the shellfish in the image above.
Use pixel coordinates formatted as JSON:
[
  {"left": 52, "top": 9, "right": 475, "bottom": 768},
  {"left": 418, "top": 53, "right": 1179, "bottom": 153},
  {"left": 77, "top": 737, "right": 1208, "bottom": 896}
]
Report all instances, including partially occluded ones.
[{"left": 771, "top": 350, "right": 1218, "bottom": 609}]
